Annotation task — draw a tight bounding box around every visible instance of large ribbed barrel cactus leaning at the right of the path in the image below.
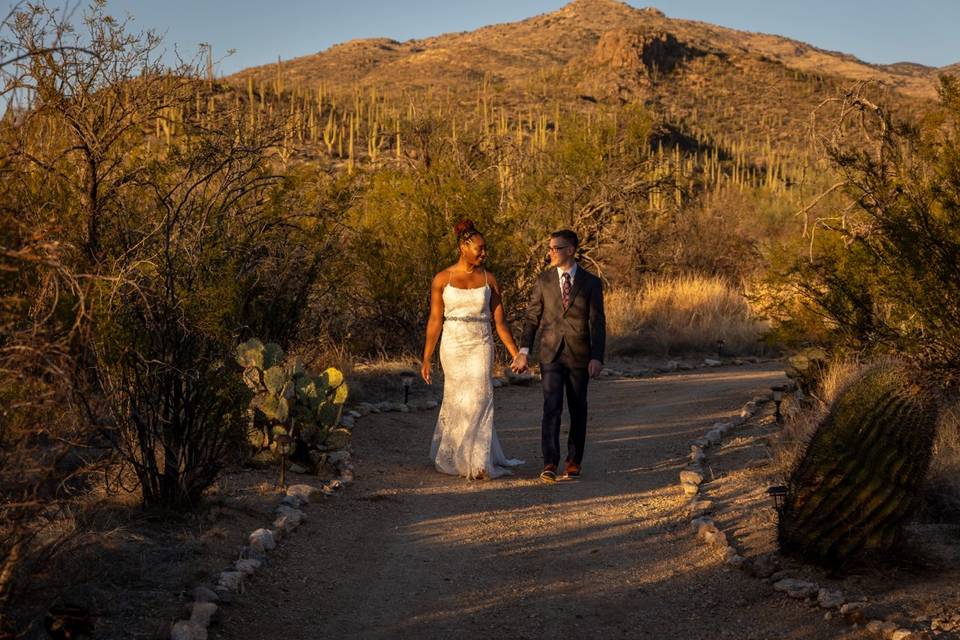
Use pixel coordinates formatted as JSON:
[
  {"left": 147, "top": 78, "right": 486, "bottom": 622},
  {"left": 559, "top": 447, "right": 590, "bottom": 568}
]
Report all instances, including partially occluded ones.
[{"left": 778, "top": 364, "right": 937, "bottom": 569}]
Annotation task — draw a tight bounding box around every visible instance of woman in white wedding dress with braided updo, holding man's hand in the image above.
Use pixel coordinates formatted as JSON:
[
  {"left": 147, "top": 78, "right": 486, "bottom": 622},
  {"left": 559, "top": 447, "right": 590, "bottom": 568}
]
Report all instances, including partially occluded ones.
[{"left": 420, "top": 220, "right": 523, "bottom": 479}]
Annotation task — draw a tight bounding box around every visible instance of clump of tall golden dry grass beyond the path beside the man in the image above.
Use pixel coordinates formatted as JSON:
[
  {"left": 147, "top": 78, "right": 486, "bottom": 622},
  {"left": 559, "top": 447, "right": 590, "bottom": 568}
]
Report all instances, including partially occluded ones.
[{"left": 605, "top": 276, "right": 764, "bottom": 355}]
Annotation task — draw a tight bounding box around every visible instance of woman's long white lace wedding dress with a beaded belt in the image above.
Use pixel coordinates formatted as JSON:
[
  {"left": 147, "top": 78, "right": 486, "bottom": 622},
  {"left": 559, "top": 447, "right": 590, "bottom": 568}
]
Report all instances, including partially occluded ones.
[{"left": 430, "top": 283, "right": 523, "bottom": 479}]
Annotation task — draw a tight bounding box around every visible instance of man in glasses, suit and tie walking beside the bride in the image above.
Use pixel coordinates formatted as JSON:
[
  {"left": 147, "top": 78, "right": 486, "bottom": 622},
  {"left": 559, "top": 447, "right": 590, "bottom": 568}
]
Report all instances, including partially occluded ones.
[{"left": 514, "top": 229, "right": 606, "bottom": 482}]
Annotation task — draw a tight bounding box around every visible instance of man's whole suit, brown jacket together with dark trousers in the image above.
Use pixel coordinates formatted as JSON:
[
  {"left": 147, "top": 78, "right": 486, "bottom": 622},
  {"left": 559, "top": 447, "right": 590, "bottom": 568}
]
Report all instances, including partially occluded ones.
[{"left": 520, "top": 265, "right": 606, "bottom": 465}]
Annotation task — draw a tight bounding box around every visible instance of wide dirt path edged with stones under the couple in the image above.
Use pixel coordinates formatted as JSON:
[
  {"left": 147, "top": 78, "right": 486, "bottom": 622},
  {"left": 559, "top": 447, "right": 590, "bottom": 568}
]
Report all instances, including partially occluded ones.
[{"left": 211, "top": 365, "right": 841, "bottom": 640}]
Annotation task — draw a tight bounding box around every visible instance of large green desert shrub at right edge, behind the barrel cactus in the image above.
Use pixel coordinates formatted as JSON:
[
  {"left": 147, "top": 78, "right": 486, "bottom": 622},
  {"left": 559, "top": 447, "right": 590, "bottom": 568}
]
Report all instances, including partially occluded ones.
[{"left": 785, "top": 77, "right": 960, "bottom": 372}]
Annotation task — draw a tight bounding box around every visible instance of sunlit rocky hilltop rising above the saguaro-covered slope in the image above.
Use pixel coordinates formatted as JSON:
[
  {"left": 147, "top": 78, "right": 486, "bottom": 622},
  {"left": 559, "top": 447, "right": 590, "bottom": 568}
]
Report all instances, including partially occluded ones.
[{"left": 225, "top": 0, "right": 960, "bottom": 180}]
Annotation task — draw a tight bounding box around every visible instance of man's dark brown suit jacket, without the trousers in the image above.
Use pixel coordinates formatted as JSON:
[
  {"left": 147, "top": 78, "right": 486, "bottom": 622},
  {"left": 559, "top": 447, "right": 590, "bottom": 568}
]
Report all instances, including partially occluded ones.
[{"left": 520, "top": 264, "right": 607, "bottom": 369}]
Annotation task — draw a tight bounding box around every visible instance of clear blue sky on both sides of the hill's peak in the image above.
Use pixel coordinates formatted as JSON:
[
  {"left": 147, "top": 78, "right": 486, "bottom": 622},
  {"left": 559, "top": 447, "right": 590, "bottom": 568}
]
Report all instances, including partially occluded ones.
[{"left": 33, "top": 0, "right": 960, "bottom": 74}]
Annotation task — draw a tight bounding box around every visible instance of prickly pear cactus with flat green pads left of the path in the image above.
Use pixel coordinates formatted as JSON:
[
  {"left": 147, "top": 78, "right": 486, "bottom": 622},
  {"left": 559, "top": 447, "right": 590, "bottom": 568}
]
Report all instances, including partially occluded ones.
[{"left": 237, "top": 338, "right": 348, "bottom": 458}]
